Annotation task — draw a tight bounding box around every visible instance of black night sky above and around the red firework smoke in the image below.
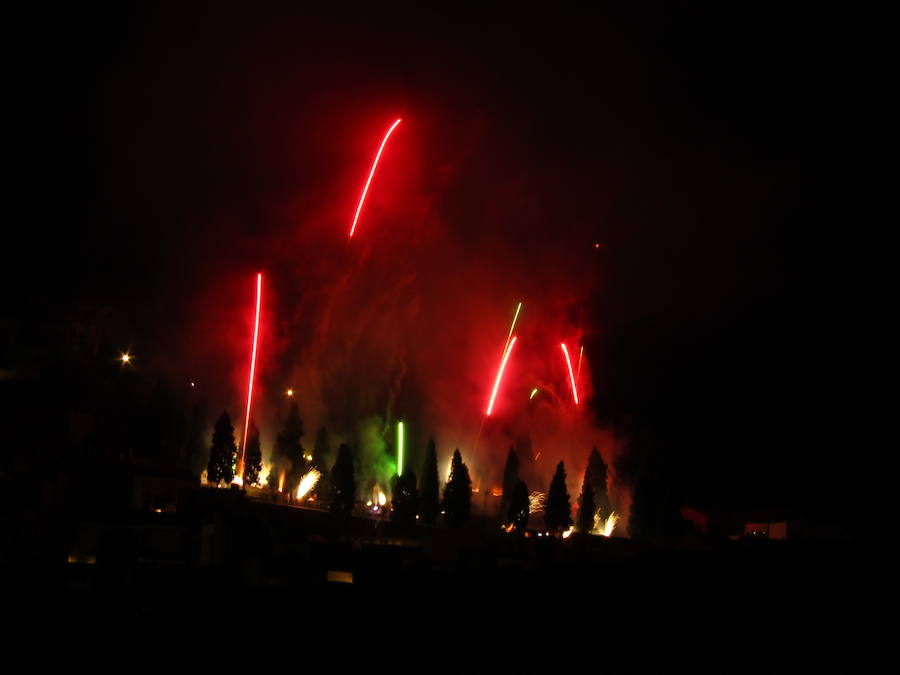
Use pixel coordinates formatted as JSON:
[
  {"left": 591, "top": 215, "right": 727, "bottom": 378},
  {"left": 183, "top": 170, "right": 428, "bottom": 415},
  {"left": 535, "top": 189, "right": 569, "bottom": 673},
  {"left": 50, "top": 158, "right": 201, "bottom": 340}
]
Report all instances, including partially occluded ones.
[{"left": 12, "top": 3, "right": 877, "bottom": 508}]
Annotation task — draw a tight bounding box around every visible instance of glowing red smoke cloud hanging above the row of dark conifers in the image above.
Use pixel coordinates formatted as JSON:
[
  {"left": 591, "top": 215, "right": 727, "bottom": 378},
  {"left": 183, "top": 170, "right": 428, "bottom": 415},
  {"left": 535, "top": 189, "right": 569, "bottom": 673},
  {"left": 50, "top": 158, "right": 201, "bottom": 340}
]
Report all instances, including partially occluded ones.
[{"left": 178, "top": 108, "right": 617, "bottom": 512}]
